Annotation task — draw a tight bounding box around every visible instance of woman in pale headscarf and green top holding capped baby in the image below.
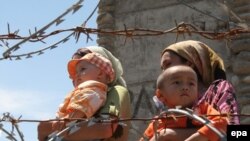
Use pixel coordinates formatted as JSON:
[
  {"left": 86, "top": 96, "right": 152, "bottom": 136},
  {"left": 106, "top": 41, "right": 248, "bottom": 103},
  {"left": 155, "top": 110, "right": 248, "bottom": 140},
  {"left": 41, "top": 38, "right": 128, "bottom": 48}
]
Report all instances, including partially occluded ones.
[{"left": 38, "top": 46, "right": 130, "bottom": 141}]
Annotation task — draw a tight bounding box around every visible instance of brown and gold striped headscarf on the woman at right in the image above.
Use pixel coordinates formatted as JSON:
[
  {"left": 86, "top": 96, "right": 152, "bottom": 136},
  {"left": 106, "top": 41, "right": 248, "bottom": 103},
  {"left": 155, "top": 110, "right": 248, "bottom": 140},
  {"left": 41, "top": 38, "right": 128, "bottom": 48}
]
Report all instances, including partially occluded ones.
[{"left": 162, "top": 40, "right": 225, "bottom": 86}]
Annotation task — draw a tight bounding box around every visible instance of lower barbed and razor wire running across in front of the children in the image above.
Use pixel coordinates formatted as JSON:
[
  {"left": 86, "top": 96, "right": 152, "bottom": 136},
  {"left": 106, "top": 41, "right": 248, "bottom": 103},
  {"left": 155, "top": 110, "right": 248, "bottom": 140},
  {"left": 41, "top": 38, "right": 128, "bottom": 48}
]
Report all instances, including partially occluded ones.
[{"left": 0, "top": 108, "right": 250, "bottom": 141}]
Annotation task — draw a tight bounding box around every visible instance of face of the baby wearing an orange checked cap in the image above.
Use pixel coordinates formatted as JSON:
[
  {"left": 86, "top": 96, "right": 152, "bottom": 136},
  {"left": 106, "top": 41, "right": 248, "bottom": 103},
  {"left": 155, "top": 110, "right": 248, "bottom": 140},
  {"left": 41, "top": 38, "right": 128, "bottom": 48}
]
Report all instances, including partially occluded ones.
[{"left": 73, "top": 61, "right": 101, "bottom": 87}]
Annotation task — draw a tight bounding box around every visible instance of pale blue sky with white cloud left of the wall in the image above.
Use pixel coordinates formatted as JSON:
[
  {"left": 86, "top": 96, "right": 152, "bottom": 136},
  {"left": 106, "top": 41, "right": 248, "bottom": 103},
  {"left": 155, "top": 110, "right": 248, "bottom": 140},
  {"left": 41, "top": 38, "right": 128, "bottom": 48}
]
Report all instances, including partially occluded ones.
[{"left": 0, "top": 0, "right": 98, "bottom": 141}]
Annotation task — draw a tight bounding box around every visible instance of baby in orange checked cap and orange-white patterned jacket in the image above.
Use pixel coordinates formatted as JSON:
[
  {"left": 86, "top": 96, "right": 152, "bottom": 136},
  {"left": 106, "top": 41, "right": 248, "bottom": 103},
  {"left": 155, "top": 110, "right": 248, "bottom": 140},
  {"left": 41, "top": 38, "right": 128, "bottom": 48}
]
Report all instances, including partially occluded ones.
[{"left": 57, "top": 53, "right": 114, "bottom": 118}]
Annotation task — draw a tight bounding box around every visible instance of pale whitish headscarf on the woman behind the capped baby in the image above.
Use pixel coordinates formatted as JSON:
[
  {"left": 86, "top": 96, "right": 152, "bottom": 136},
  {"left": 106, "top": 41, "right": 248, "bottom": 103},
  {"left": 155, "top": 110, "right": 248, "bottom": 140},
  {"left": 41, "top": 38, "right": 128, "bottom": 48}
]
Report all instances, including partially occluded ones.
[{"left": 74, "top": 46, "right": 127, "bottom": 87}]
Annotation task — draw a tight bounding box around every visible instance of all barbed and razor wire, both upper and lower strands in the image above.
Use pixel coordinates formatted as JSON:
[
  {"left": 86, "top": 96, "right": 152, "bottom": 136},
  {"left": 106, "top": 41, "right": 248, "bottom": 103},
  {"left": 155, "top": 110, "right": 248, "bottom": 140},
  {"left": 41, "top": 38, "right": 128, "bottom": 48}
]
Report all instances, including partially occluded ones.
[{"left": 0, "top": 0, "right": 250, "bottom": 141}]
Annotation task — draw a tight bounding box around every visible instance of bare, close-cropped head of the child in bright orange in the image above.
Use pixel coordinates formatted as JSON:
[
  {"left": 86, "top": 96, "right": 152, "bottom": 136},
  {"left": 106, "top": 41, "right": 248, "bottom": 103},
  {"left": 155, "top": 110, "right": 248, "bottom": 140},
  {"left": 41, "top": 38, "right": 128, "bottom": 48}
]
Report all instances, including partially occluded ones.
[{"left": 156, "top": 65, "right": 198, "bottom": 108}]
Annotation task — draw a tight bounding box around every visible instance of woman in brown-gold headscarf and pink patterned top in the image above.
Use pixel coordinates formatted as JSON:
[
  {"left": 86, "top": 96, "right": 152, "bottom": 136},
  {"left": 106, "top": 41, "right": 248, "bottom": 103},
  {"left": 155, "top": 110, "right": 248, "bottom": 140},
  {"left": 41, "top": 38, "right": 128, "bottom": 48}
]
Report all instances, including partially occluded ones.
[{"left": 148, "top": 40, "right": 239, "bottom": 141}]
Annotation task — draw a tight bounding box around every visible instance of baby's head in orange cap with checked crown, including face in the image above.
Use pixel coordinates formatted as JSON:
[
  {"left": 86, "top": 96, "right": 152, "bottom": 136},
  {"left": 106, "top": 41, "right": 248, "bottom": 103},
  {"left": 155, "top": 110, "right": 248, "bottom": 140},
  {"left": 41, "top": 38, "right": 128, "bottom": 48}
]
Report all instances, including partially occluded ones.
[{"left": 68, "top": 53, "right": 115, "bottom": 87}]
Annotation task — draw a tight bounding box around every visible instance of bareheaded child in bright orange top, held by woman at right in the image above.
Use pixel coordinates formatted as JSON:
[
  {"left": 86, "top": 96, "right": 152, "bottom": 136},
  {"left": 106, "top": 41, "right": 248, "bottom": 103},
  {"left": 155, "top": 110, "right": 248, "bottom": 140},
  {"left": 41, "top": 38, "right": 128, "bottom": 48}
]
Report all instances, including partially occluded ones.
[{"left": 141, "top": 66, "right": 227, "bottom": 141}]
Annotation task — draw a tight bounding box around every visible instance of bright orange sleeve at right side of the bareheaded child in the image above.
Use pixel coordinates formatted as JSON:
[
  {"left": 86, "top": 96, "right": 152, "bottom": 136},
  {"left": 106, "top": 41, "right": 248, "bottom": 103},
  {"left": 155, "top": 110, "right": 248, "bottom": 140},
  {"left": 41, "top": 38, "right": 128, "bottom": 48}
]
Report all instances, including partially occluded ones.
[{"left": 198, "top": 103, "right": 227, "bottom": 141}]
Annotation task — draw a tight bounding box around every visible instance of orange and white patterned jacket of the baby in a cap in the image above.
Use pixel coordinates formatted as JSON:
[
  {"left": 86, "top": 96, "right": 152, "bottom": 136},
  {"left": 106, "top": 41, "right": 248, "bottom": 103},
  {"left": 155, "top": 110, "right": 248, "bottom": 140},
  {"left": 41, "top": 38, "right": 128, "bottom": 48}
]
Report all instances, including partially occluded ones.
[{"left": 57, "top": 80, "right": 107, "bottom": 118}]
